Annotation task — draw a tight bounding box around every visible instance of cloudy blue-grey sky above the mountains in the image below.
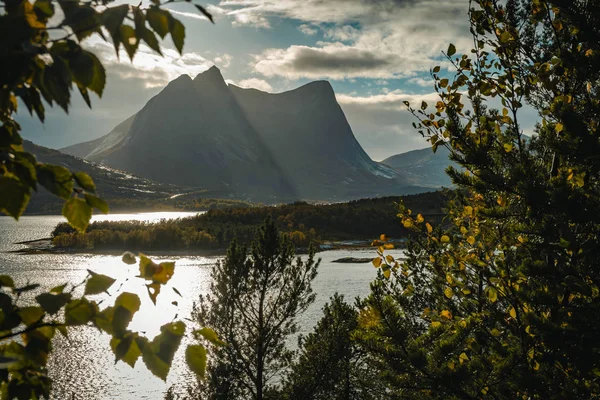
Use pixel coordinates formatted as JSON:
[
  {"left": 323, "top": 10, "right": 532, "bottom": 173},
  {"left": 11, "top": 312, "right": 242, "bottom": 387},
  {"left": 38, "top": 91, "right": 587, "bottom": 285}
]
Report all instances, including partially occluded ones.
[{"left": 18, "top": 0, "right": 536, "bottom": 160}]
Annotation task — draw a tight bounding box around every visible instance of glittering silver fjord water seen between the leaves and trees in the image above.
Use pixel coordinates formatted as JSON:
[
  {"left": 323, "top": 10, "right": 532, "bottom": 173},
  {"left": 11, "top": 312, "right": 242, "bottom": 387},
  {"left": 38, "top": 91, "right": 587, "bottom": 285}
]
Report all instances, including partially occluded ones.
[{"left": 0, "top": 213, "right": 394, "bottom": 400}]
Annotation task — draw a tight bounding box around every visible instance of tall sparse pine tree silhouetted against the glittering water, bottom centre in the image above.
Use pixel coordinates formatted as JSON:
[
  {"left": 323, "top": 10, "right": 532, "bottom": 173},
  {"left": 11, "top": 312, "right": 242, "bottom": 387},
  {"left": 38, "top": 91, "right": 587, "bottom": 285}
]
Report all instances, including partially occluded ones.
[{"left": 194, "top": 218, "right": 319, "bottom": 400}]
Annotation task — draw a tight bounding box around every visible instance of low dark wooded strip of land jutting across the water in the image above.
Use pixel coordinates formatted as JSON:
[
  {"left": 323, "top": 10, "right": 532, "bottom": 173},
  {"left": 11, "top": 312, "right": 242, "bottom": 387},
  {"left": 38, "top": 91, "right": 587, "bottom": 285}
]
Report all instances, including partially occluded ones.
[{"left": 52, "top": 192, "right": 446, "bottom": 251}]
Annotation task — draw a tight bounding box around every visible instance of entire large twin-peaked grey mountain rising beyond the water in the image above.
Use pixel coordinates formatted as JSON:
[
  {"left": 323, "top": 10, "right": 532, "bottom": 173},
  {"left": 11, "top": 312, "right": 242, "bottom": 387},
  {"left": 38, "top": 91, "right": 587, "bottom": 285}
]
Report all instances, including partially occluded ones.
[{"left": 62, "top": 67, "right": 422, "bottom": 202}]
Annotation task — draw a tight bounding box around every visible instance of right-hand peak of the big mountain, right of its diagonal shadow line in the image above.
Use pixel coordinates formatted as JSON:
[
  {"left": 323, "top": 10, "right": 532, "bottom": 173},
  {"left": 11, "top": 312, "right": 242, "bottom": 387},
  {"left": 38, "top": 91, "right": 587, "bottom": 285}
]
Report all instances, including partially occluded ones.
[{"left": 230, "top": 81, "right": 409, "bottom": 199}]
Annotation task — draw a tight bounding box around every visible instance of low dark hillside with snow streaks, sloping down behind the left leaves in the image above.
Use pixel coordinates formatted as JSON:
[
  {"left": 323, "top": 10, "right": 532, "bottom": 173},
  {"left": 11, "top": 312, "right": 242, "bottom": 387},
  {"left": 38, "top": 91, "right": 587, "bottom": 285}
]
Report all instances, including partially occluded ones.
[{"left": 23, "top": 140, "right": 185, "bottom": 213}]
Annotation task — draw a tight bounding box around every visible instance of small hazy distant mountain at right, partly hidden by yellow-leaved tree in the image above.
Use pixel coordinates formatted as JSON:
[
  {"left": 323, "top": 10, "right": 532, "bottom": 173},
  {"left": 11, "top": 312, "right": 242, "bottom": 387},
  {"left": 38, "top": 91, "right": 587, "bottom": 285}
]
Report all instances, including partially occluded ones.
[{"left": 382, "top": 146, "right": 453, "bottom": 188}]
